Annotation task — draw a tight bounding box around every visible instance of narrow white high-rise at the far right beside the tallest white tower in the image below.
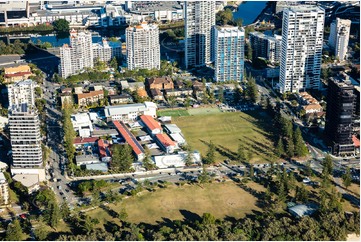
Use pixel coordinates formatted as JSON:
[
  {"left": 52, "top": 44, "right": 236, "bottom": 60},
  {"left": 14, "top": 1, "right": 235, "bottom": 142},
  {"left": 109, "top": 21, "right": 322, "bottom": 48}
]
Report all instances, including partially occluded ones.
[{"left": 328, "top": 18, "right": 351, "bottom": 61}]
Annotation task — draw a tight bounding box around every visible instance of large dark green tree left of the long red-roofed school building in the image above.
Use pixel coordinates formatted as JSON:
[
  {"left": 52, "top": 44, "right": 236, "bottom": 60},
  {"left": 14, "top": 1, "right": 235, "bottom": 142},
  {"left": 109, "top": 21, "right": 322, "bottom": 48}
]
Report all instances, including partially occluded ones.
[{"left": 110, "top": 144, "right": 134, "bottom": 172}]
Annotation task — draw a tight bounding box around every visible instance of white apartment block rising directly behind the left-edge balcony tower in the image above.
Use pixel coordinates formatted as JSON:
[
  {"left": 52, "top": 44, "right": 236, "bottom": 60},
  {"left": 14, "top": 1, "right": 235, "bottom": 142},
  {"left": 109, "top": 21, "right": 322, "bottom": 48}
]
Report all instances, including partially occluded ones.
[{"left": 8, "top": 79, "right": 35, "bottom": 108}]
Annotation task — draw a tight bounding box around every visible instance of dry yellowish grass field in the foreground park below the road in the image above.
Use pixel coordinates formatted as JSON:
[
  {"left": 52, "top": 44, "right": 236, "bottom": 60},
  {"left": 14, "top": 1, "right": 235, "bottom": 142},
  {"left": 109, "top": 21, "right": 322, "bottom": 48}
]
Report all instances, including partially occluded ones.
[{"left": 88, "top": 182, "right": 260, "bottom": 224}]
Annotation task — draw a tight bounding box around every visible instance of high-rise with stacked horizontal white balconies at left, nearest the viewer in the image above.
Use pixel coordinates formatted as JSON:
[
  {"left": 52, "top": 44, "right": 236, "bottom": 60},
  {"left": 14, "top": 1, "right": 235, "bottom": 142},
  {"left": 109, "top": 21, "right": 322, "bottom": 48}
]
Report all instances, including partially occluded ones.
[{"left": 9, "top": 103, "right": 43, "bottom": 169}]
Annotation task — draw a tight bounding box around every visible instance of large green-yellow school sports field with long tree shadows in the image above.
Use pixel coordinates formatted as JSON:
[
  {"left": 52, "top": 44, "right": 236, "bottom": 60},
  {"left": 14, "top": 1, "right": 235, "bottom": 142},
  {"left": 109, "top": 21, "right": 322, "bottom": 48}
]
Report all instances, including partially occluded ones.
[{"left": 173, "top": 112, "right": 277, "bottom": 163}]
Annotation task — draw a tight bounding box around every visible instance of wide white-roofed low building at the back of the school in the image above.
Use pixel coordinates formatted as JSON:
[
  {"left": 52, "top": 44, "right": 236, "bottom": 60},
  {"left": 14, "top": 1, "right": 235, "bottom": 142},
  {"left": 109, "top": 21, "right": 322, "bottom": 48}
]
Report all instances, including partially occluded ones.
[{"left": 104, "top": 102, "right": 157, "bottom": 122}]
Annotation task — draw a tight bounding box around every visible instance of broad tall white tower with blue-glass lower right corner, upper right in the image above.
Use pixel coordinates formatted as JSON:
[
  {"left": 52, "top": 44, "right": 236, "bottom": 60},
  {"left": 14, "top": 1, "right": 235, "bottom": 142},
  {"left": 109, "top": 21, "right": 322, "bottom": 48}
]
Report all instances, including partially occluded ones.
[{"left": 280, "top": 5, "right": 325, "bottom": 93}]
